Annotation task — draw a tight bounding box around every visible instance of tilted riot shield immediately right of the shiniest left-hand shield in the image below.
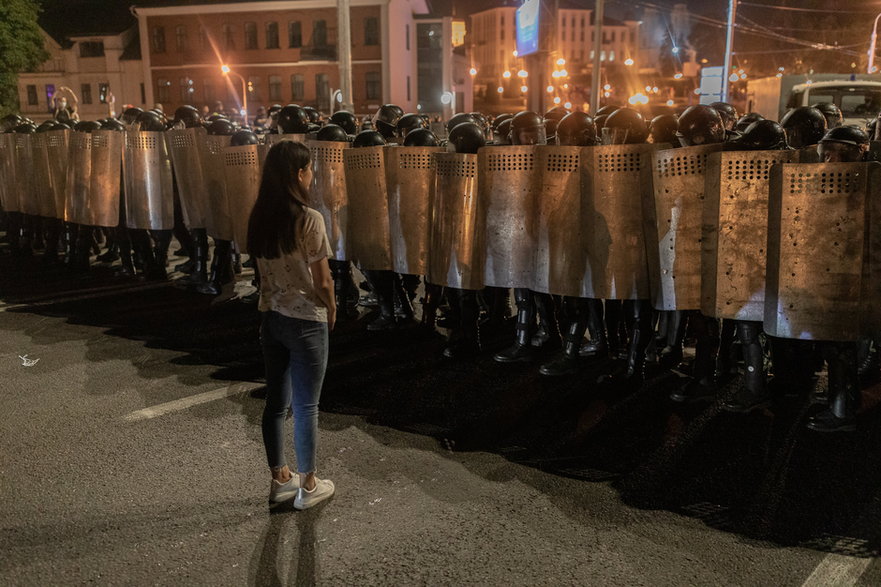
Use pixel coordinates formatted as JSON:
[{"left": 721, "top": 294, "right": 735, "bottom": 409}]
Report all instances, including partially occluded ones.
[{"left": 166, "top": 128, "right": 210, "bottom": 229}]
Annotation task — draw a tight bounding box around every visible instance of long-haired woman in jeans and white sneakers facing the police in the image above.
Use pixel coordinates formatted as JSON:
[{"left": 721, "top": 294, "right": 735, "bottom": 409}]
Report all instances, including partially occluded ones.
[{"left": 248, "top": 141, "right": 336, "bottom": 510}]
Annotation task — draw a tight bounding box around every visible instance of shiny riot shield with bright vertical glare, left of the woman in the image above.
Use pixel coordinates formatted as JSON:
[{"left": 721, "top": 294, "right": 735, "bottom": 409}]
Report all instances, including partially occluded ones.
[{"left": 123, "top": 131, "right": 174, "bottom": 230}]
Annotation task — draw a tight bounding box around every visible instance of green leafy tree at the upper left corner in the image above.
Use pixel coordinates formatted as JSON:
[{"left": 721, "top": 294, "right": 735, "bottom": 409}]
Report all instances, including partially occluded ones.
[{"left": 0, "top": 0, "right": 49, "bottom": 116}]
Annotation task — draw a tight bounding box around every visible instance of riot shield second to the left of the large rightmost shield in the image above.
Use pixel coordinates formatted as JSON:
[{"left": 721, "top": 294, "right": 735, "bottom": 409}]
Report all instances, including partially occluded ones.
[{"left": 643, "top": 144, "right": 722, "bottom": 310}]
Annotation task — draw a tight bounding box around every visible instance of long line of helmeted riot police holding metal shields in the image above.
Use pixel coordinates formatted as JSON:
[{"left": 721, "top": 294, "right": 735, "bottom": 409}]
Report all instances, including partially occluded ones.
[{"left": 0, "top": 103, "right": 881, "bottom": 430}]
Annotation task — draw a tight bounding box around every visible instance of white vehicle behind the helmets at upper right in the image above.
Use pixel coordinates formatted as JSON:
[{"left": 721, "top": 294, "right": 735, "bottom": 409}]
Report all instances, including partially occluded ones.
[{"left": 747, "top": 73, "right": 881, "bottom": 127}]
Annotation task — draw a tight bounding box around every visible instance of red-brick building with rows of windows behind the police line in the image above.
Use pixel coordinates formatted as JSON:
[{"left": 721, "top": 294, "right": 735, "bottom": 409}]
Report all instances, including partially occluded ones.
[{"left": 134, "top": 0, "right": 427, "bottom": 115}]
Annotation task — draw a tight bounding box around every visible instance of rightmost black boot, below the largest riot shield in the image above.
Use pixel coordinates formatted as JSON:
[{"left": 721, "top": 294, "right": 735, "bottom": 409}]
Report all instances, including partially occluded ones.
[{"left": 807, "top": 342, "right": 861, "bottom": 432}]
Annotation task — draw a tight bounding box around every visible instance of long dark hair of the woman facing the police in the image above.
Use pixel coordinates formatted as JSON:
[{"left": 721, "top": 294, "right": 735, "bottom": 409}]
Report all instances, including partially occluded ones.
[{"left": 248, "top": 141, "right": 311, "bottom": 259}]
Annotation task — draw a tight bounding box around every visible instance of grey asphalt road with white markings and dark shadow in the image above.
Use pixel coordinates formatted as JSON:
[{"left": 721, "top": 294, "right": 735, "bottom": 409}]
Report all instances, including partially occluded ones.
[{"left": 0, "top": 248, "right": 881, "bottom": 586}]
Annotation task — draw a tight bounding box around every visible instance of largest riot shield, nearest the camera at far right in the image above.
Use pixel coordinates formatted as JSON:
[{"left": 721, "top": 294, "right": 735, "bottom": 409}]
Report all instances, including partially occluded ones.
[{"left": 764, "top": 163, "right": 881, "bottom": 341}]
